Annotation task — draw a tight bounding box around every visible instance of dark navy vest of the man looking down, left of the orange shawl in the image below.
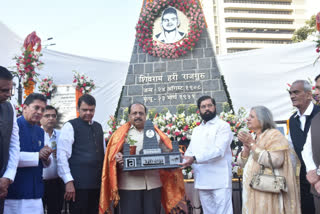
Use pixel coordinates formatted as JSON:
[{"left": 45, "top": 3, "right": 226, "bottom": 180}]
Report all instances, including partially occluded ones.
[{"left": 69, "top": 118, "right": 104, "bottom": 189}]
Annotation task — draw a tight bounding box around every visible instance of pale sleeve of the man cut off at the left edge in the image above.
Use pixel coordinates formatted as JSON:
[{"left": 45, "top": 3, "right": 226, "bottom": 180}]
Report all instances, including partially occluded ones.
[{"left": 2, "top": 103, "right": 20, "bottom": 181}]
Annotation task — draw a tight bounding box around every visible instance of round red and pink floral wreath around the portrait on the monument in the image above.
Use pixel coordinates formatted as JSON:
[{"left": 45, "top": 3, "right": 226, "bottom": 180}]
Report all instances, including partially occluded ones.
[{"left": 136, "top": 0, "right": 206, "bottom": 58}]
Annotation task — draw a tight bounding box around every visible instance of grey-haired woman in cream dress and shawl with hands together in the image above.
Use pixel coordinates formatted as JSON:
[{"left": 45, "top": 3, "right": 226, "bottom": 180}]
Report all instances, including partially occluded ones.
[{"left": 238, "top": 106, "right": 301, "bottom": 214}]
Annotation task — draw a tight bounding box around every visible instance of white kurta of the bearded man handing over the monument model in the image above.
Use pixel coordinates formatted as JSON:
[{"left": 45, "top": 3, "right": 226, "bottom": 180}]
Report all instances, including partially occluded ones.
[{"left": 185, "top": 116, "right": 233, "bottom": 189}]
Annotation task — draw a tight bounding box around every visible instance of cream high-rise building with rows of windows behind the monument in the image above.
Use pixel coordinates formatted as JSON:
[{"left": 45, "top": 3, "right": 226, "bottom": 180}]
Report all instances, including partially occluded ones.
[{"left": 213, "top": 0, "right": 316, "bottom": 54}]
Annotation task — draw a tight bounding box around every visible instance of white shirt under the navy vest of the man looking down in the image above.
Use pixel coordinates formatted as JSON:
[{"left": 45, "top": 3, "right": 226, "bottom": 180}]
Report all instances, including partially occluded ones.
[{"left": 57, "top": 122, "right": 106, "bottom": 183}]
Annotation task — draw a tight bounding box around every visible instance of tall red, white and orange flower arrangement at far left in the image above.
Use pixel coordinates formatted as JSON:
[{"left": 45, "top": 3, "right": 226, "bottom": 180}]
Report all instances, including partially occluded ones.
[{"left": 13, "top": 32, "right": 43, "bottom": 98}]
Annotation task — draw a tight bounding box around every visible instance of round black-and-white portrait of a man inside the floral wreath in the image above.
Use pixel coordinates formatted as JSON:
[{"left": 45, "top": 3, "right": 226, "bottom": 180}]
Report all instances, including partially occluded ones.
[{"left": 153, "top": 7, "right": 189, "bottom": 44}]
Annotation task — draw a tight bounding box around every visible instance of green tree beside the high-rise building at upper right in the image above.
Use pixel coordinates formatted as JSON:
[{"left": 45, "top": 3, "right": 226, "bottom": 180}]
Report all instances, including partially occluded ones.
[{"left": 292, "top": 15, "right": 317, "bottom": 42}]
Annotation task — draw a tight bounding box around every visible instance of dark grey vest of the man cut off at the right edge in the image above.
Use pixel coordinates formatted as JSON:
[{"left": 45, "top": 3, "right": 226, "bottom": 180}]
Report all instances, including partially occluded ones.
[{"left": 311, "top": 113, "right": 320, "bottom": 197}]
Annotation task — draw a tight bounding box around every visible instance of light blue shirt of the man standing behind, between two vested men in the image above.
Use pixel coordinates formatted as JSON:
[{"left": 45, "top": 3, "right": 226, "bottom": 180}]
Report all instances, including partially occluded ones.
[{"left": 42, "top": 129, "right": 60, "bottom": 180}]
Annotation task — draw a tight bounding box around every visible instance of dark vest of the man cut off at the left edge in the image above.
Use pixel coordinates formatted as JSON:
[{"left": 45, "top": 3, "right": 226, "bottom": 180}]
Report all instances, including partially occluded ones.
[{"left": 0, "top": 102, "right": 13, "bottom": 178}]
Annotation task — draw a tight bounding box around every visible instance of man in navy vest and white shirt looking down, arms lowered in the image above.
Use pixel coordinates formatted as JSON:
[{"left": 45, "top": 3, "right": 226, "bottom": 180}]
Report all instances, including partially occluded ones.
[{"left": 57, "top": 94, "right": 105, "bottom": 214}]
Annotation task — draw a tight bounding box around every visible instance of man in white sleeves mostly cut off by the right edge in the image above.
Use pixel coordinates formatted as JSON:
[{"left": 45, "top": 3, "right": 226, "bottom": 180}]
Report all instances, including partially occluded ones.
[{"left": 302, "top": 75, "right": 320, "bottom": 213}]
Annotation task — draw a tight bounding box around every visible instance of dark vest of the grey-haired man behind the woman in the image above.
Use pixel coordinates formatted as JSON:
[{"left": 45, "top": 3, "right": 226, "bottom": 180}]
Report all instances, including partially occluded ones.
[{"left": 289, "top": 105, "right": 320, "bottom": 182}]
